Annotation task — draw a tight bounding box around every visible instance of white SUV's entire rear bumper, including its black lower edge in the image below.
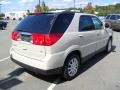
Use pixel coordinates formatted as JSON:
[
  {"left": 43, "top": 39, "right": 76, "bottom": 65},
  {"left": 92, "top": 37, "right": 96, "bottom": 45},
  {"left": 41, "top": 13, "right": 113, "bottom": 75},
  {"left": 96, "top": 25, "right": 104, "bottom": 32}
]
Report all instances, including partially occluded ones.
[{"left": 10, "top": 48, "right": 64, "bottom": 75}]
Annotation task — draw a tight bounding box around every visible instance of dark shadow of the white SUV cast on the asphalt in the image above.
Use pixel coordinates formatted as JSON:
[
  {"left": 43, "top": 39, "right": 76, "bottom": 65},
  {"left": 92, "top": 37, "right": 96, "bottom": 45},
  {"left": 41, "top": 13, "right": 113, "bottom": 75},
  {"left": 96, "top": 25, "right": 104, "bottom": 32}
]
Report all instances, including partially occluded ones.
[{"left": 0, "top": 46, "right": 116, "bottom": 90}]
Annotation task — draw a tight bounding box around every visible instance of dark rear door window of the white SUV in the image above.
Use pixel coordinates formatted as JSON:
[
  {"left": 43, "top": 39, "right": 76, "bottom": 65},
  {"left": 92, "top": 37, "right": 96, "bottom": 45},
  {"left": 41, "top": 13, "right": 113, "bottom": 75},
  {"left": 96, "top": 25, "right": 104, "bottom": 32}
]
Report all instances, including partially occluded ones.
[{"left": 79, "top": 15, "right": 94, "bottom": 31}]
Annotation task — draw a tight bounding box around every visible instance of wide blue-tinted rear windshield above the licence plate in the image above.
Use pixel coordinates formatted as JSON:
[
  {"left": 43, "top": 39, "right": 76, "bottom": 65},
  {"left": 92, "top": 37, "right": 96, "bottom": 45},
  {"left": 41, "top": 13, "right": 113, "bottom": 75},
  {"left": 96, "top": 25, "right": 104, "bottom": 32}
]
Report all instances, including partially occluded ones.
[{"left": 15, "top": 14, "right": 54, "bottom": 34}]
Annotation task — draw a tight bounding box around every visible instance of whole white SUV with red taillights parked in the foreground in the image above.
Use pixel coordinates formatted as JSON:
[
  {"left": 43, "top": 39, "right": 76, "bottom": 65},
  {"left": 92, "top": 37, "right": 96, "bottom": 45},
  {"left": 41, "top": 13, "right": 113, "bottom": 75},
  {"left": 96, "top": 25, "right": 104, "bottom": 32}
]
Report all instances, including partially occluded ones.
[{"left": 10, "top": 12, "right": 113, "bottom": 80}]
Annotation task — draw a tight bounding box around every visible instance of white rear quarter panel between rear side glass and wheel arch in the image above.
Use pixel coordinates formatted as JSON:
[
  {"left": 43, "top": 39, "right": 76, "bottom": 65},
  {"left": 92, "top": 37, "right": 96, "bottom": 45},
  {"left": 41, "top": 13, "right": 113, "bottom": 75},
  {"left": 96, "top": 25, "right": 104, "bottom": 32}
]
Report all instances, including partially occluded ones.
[{"left": 45, "top": 14, "right": 83, "bottom": 59}]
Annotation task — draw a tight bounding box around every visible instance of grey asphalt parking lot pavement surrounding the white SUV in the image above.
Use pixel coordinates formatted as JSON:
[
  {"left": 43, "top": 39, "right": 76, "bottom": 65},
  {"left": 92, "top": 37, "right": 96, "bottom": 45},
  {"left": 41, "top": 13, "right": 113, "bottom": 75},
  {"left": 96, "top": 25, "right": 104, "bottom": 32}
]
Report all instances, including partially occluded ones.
[{"left": 0, "top": 21, "right": 120, "bottom": 90}]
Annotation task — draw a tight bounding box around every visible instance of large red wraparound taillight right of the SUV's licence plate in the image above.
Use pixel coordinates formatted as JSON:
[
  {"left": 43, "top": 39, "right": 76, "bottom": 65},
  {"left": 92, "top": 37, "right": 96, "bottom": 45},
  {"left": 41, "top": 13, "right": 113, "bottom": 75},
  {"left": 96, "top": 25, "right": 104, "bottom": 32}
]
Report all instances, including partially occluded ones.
[{"left": 32, "top": 33, "right": 63, "bottom": 46}]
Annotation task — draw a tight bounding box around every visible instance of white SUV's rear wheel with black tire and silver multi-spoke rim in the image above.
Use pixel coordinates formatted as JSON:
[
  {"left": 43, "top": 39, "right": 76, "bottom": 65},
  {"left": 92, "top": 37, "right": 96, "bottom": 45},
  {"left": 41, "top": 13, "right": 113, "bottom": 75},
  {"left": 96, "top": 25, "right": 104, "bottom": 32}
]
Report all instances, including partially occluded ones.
[{"left": 63, "top": 54, "right": 80, "bottom": 80}]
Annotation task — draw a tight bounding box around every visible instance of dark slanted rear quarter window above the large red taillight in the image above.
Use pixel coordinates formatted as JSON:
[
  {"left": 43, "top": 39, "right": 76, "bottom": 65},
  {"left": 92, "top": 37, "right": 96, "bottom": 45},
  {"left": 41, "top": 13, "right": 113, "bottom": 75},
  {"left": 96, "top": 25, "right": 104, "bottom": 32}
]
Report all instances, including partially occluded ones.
[{"left": 51, "top": 13, "right": 74, "bottom": 33}]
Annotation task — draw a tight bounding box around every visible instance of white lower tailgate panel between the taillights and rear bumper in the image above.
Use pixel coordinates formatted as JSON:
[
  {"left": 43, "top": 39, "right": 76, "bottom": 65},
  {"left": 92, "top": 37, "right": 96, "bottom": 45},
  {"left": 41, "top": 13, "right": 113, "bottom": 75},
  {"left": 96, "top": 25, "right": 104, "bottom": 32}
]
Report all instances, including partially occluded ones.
[{"left": 12, "top": 41, "right": 45, "bottom": 60}]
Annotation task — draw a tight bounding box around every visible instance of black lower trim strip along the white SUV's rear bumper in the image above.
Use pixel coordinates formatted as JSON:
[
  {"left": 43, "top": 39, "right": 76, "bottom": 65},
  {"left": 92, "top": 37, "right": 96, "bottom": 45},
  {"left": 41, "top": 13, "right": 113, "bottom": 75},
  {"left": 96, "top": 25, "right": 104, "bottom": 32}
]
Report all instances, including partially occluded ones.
[{"left": 11, "top": 56, "right": 62, "bottom": 75}]
